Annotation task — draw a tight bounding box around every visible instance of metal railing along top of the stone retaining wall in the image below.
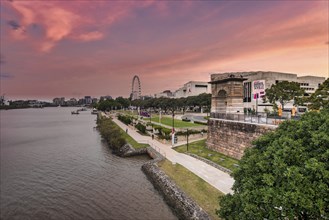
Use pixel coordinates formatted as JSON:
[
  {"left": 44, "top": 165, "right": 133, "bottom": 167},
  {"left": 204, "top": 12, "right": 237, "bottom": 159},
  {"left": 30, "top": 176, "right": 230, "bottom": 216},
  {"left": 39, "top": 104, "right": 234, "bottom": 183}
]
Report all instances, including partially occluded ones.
[{"left": 210, "top": 112, "right": 299, "bottom": 125}]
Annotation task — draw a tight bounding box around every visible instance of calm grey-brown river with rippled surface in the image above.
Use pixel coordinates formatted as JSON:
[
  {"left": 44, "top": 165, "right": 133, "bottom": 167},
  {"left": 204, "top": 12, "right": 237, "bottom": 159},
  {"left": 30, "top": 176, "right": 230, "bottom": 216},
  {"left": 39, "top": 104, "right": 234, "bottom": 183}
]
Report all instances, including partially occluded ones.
[{"left": 0, "top": 108, "right": 177, "bottom": 220}]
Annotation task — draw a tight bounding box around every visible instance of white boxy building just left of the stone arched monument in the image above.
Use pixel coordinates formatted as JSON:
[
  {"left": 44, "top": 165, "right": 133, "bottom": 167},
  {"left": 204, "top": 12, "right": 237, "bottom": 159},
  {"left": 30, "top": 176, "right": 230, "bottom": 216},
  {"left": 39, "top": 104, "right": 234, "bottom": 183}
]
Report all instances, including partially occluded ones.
[{"left": 174, "top": 81, "right": 211, "bottom": 98}]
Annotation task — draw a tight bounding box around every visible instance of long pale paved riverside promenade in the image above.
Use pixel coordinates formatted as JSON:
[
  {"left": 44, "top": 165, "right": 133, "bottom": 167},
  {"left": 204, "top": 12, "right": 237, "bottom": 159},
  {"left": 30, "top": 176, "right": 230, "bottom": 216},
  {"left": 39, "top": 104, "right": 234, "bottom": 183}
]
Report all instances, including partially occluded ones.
[{"left": 113, "top": 117, "right": 234, "bottom": 194}]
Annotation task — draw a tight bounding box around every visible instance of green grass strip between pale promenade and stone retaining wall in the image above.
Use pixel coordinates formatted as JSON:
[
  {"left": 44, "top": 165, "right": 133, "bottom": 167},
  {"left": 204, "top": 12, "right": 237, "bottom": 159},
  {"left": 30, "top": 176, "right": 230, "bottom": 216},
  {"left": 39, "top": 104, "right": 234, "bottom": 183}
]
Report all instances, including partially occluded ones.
[{"left": 173, "top": 140, "right": 239, "bottom": 170}]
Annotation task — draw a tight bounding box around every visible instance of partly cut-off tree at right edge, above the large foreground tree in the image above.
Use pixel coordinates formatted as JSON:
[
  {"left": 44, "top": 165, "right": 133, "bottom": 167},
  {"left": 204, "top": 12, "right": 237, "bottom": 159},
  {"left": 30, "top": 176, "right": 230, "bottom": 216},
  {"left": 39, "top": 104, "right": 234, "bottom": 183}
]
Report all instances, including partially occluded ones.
[{"left": 308, "top": 78, "right": 329, "bottom": 110}]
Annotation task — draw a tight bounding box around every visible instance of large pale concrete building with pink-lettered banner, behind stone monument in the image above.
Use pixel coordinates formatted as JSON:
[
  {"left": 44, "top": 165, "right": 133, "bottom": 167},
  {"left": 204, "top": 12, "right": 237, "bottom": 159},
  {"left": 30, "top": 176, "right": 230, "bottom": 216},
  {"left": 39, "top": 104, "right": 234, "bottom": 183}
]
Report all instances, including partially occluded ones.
[{"left": 211, "top": 71, "right": 325, "bottom": 112}]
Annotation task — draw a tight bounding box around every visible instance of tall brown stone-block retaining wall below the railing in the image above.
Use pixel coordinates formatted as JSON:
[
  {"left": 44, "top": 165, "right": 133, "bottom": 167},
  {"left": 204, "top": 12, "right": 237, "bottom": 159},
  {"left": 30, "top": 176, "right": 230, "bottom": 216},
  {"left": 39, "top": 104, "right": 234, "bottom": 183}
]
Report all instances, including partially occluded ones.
[{"left": 207, "top": 119, "right": 276, "bottom": 159}]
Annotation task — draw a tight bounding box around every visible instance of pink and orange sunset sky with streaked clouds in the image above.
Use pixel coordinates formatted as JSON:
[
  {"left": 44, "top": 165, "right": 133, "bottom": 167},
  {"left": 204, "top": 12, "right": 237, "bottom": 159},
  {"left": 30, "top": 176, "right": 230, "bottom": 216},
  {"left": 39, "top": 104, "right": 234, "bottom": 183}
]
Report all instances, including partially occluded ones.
[{"left": 0, "top": 0, "right": 329, "bottom": 100}]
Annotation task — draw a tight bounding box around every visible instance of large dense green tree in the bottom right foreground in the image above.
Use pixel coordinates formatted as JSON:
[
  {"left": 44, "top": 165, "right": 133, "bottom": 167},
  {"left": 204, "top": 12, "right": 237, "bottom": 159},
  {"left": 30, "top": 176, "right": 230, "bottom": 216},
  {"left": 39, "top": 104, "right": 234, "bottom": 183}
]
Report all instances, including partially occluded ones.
[{"left": 217, "top": 109, "right": 329, "bottom": 219}]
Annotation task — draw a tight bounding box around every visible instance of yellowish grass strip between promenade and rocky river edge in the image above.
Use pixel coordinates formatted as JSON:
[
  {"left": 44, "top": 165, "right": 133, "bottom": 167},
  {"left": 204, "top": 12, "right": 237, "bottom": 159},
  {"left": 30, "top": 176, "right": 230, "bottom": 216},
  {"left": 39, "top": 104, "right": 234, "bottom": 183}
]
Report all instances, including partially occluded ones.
[{"left": 159, "top": 160, "right": 223, "bottom": 219}]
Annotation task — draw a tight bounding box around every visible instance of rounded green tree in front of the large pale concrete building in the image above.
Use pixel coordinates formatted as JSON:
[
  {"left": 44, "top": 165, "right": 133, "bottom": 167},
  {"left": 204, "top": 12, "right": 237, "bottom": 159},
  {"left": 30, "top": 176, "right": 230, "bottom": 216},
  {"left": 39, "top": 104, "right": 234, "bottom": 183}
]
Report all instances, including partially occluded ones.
[{"left": 265, "top": 81, "right": 305, "bottom": 109}]
